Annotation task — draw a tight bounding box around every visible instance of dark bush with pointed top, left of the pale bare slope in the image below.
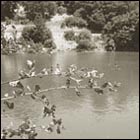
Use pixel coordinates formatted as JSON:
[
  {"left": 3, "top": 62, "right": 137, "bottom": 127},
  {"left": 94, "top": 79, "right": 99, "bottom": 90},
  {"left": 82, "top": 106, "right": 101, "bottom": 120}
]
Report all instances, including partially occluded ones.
[{"left": 22, "top": 14, "right": 55, "bottom": 48}]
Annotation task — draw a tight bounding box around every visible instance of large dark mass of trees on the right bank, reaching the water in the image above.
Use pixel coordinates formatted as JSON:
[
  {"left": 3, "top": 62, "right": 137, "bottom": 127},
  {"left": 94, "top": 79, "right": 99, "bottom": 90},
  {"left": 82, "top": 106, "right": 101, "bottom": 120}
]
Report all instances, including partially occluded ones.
[{"left": 65, "top": 1, "right": 139, "bottom": 51}]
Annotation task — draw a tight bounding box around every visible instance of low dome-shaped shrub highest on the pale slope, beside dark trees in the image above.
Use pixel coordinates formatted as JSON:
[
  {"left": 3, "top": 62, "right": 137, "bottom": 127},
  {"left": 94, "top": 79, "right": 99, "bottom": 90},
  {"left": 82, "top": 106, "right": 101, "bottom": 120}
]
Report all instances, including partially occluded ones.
[{"left": 61, "top": 17, "right": 87, "bottom": 28}]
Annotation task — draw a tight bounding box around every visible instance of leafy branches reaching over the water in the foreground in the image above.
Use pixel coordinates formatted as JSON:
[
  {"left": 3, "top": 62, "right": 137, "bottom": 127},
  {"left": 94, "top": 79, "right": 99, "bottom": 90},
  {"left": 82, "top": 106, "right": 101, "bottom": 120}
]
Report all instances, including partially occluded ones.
[{"left": 1, "top": 60, "right": 121, "bottom": 139}]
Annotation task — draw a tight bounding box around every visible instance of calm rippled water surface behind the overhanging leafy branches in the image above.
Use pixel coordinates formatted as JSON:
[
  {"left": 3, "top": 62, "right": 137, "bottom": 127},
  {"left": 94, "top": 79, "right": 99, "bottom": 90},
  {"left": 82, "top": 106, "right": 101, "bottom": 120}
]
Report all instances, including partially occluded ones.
[{"left": 1, "top": 52, "right": 139, "bottom": 139}]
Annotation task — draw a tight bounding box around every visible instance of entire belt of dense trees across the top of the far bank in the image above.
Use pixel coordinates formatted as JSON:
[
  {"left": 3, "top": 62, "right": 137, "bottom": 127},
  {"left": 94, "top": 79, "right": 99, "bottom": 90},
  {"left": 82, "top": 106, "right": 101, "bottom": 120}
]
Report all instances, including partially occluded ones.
[{"left": 1, "top": 1, "right": 139, "bottom": 51}]
